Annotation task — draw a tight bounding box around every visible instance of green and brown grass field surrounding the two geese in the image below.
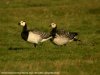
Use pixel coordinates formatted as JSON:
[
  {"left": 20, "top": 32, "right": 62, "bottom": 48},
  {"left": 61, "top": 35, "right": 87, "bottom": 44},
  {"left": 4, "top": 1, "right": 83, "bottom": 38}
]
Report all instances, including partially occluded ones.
[{"left": 0, "top": 0, "right": 100, "bottom": 75}]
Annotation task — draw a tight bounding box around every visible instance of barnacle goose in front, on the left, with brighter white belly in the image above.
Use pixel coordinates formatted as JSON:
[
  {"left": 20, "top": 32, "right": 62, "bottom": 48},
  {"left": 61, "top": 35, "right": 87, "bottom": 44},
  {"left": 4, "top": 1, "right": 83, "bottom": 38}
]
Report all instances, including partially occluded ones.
[{"left": 18, "top": 21, "right": 51, "bottom": 47}]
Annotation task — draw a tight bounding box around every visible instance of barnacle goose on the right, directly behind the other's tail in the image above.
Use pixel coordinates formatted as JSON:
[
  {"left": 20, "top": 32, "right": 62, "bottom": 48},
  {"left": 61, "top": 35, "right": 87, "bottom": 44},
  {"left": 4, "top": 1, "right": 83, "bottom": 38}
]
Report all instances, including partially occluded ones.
[{"left": 50, "top": 23, "right": 79, "bottom": 45}]
